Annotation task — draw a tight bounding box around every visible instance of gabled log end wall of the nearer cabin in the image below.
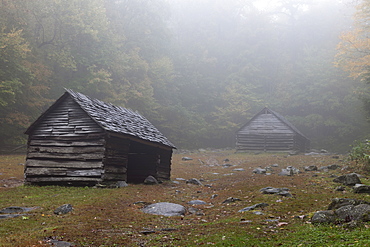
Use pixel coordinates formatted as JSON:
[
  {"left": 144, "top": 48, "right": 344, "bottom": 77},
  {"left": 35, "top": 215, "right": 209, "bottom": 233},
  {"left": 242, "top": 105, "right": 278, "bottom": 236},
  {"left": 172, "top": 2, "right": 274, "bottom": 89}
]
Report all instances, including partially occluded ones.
[{"left": 25, "top": 98, "right": 105, "bottom": 184}]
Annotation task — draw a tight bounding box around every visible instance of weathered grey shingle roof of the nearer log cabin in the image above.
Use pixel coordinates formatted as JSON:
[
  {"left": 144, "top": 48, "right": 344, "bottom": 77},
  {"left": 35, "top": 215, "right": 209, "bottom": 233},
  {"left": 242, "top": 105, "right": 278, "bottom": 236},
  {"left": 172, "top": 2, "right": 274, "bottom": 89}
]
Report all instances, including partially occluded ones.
[{"left": 26, "top": 89, "right": 176, "bottom": 148}]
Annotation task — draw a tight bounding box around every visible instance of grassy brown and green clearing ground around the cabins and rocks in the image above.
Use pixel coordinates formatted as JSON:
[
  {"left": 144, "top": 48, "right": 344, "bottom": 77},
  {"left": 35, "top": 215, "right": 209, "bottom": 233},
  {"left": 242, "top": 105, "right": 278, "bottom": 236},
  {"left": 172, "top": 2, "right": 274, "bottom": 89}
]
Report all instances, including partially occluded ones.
[{"left": 0, "top": 150, "right": 370, "bottom": 247}]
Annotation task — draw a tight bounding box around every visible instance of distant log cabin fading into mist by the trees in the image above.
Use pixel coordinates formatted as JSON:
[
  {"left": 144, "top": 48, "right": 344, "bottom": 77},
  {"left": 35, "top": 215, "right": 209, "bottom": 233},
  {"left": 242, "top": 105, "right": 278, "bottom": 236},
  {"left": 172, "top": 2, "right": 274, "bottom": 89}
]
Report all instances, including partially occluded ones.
[{"left": 236, "top": 107, "right": 310, "bottom": 152}]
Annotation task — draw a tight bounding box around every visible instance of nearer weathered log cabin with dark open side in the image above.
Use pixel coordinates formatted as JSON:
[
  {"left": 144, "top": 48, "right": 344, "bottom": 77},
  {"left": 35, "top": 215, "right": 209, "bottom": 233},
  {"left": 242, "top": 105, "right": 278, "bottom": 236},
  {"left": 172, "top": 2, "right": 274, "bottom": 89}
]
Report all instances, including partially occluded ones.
[{"left": 25, "top": 89, "right": 176, "bottom": 185}]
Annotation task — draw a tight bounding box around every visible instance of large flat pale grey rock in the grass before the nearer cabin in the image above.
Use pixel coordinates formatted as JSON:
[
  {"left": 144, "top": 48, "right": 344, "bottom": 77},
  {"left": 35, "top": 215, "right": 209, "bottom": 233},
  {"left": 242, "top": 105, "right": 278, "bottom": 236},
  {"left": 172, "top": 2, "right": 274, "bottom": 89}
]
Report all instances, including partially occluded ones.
[{"left": 142, "top": 202, "right": 186, "bottom": 216}]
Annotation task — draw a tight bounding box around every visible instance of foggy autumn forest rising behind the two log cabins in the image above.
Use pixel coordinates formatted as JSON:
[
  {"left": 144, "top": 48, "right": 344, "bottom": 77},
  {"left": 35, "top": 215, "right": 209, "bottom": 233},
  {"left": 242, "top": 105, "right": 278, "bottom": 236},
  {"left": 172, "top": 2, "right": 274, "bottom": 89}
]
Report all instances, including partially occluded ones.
[{"left": 0, "top": 0, "right": 370, "bottom": 152}]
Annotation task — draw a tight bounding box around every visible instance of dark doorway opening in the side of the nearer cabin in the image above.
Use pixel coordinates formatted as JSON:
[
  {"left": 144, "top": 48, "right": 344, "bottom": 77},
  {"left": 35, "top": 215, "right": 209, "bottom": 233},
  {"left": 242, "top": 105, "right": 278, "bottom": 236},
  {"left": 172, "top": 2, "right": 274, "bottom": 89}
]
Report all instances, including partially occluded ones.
[{"left": 127, "top": 141, "right": 158, "bottom": 183}]
